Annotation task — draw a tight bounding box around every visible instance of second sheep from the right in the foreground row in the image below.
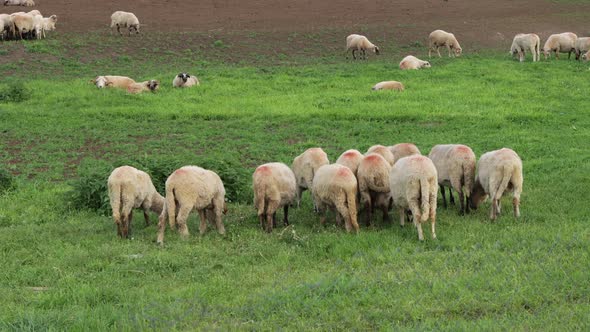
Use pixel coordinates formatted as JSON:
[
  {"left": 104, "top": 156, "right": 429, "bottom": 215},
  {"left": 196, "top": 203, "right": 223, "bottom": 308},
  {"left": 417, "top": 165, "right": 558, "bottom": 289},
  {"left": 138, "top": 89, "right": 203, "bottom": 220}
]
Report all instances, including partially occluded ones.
[{"left": 428, "top": 144, "right": 476, "bottom": 214}]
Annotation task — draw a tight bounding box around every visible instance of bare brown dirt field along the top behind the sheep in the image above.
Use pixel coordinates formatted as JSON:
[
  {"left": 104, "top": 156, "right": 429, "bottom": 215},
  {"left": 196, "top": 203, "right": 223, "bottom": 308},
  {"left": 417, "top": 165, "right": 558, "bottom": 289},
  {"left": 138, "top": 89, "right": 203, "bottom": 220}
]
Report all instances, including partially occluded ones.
[{"left": 1, "top": 0, "right": 590, "bottom": 46}]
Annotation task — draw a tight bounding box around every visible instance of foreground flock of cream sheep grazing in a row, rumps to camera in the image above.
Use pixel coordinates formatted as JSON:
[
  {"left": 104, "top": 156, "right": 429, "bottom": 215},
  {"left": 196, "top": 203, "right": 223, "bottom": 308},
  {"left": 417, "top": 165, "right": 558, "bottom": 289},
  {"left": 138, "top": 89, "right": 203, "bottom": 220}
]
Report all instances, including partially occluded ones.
[{"left": 108, "top": 143, "right": 523, "bottom": 244}]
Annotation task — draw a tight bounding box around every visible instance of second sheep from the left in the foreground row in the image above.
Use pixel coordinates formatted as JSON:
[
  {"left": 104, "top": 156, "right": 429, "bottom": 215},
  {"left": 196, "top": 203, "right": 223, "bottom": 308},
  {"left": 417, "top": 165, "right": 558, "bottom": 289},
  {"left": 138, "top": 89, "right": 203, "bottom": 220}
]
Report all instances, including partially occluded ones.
[{"left": 157, "top": 166, "right": 226, "bottom": 244}]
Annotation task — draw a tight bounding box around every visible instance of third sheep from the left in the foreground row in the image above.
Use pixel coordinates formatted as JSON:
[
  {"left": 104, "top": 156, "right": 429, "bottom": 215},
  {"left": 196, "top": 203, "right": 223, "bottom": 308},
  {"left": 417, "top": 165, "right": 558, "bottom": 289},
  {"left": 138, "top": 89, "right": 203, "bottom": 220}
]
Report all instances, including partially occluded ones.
[{"left": 252, "top": 163, "right": 297, "bottom": 233}]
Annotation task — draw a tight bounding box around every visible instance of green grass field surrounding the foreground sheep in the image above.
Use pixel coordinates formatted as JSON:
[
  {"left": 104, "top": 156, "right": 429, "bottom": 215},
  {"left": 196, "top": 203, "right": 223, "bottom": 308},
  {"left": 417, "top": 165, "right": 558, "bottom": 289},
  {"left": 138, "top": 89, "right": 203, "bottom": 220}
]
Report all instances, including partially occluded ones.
[{"left": 0, "top": 54, "right": 590, "bottom": 330}]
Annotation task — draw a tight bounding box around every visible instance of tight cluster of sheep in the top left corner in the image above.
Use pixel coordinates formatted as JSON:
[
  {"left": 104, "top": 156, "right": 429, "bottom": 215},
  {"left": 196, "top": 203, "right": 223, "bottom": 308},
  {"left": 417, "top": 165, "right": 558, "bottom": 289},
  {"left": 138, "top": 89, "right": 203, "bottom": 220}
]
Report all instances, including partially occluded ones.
[{"left": 0, "top": 7, "right": 57, "bottom": 40}]
